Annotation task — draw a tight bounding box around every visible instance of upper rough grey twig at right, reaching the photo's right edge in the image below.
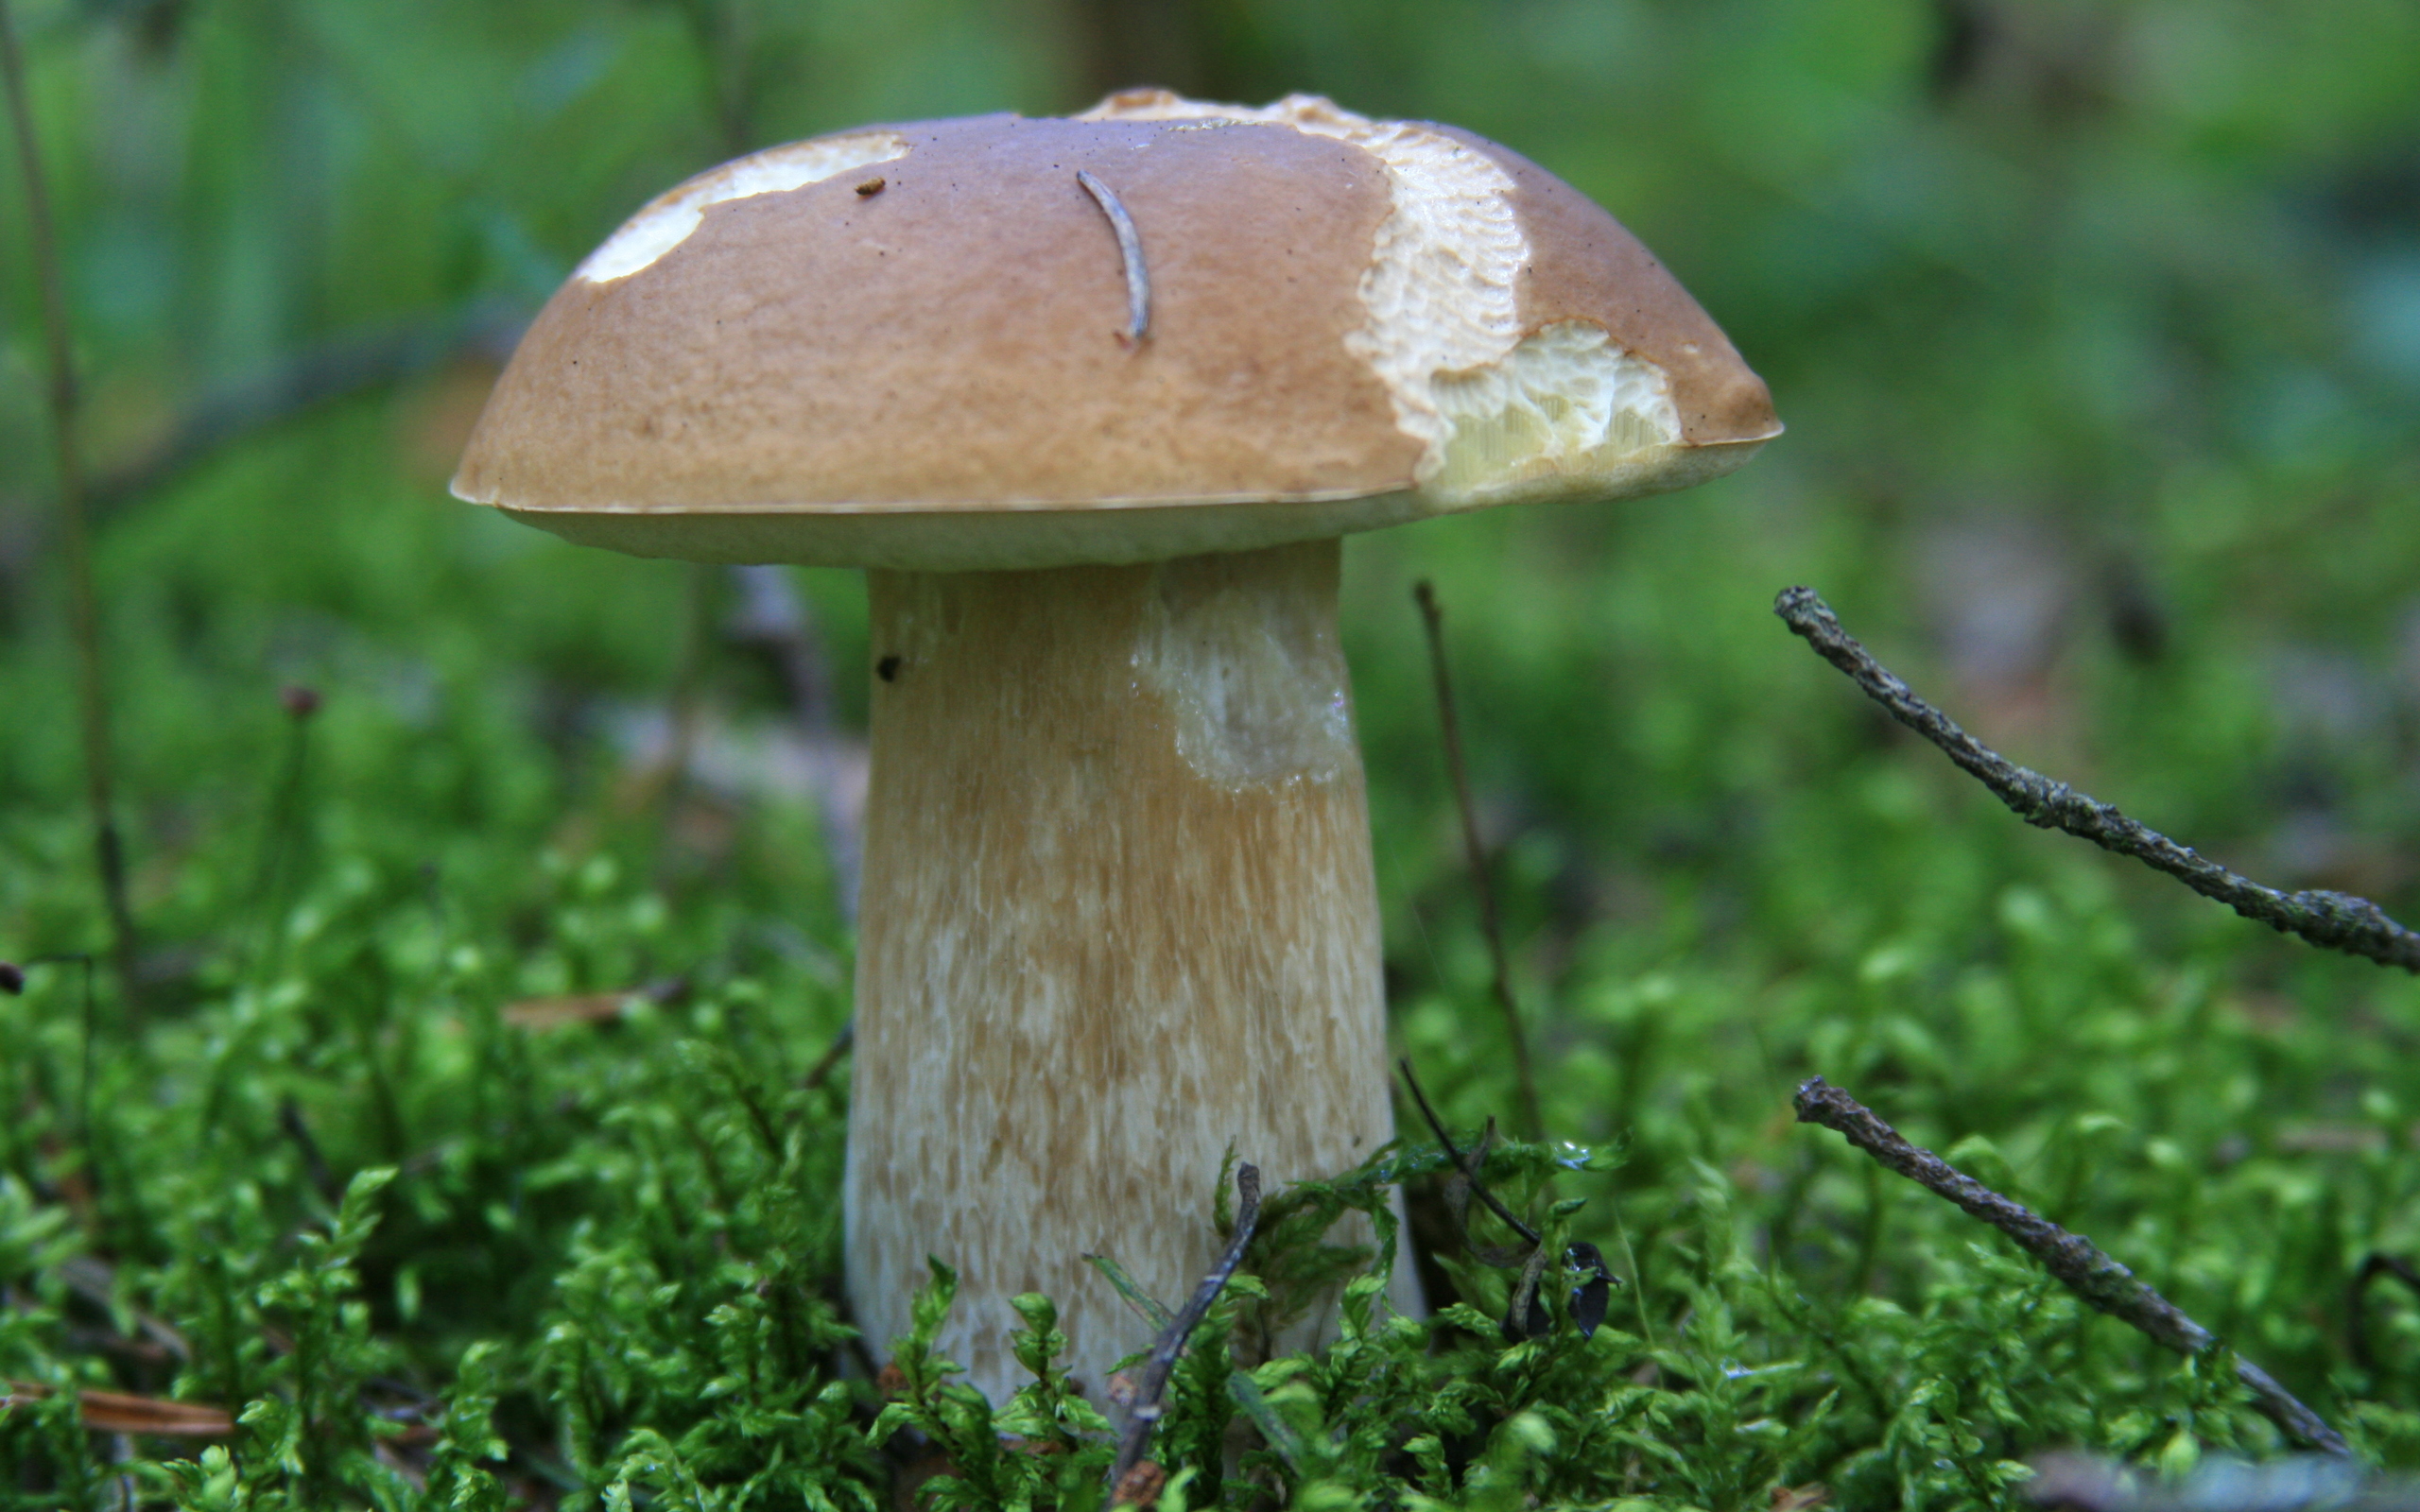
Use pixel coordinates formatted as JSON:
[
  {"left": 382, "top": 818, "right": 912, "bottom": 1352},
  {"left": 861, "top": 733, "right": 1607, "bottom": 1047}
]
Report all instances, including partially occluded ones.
[{"left": 1773, "top": 588, "right": 2420, "bottom": 972}]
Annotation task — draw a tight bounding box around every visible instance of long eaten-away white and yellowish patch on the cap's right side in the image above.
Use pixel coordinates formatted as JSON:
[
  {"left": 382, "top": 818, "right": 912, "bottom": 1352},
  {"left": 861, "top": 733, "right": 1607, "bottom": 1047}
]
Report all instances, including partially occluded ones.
[{"left": 1081, "top": 90, "right": 1680, "bottom": 498}]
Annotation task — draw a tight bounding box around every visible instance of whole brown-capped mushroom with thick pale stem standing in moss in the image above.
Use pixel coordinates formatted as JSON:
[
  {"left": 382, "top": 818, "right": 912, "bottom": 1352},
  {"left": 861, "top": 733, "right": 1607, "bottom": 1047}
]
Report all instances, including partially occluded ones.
[{"left": 455, "top": 92, "right": 1779, "bottom": 1400}]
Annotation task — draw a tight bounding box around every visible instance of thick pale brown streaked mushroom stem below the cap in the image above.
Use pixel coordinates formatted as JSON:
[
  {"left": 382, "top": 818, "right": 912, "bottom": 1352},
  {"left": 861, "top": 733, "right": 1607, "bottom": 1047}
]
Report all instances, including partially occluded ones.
[{"left": 847, "top": 540, "right": 1418, "bottom": 1403}]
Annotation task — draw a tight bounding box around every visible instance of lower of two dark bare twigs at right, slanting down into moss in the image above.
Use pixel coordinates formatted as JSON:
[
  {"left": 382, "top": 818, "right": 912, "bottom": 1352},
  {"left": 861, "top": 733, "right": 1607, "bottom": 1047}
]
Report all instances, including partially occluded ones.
[{"left": 1793, "top": 1076, "right": 2352, "bottom": 1456}]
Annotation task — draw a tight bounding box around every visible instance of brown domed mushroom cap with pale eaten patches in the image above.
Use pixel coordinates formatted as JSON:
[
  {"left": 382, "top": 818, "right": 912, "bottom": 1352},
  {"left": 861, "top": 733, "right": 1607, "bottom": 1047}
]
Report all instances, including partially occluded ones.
[{"left": 455, "top": 92, "right": 1781, "bottom": 571}]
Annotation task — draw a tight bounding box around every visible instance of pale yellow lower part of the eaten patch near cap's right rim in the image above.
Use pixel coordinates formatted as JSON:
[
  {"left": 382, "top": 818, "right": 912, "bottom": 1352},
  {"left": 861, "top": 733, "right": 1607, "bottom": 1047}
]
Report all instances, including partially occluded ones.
[{"left": 1423, "top": 319, "right": 1680, "bottom": 503}]
